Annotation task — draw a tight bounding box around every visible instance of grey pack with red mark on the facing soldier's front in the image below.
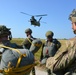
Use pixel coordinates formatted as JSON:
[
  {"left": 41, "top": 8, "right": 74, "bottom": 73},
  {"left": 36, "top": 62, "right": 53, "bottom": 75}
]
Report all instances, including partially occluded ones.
[{"left": 43, "top": 40, "right": 57, "bottom": 58}]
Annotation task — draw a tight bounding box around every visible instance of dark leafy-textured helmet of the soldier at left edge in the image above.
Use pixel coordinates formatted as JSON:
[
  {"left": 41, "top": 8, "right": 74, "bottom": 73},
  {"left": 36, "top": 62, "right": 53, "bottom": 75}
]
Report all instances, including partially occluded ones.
[{"left": 0, "top": 25, "right": 12, "bottom": 40}]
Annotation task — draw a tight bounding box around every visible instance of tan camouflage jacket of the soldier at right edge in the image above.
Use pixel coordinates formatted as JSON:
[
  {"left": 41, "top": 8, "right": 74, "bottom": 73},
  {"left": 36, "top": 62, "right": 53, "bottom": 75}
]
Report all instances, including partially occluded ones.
[{"left": 46, "top": 37, "right": 76, "bottom": 71}]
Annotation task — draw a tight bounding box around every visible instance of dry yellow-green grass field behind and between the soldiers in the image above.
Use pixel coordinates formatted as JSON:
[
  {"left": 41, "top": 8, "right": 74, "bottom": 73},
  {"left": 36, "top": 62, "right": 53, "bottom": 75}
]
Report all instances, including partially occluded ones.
[{"left": 11, "top": 38, "right": 67, "bottom": 60}]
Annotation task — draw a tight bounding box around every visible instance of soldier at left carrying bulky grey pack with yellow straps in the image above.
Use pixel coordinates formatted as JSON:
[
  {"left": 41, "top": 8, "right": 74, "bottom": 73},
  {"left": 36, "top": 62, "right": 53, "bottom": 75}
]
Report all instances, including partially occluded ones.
[{"left": 0, "top": 25, "right": 41, "bottom": 75}]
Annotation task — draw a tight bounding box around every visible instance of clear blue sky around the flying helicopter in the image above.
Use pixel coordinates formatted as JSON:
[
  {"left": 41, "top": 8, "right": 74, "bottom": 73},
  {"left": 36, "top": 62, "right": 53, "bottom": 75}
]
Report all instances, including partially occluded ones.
[{"left": 0, "top": 0, "right": 76, "bottom": 39}]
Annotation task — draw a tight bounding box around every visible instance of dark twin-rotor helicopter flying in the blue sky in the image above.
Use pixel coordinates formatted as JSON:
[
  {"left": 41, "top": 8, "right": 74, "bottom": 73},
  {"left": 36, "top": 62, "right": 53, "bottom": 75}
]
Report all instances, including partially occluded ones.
[{"left": 21, "top": 12, "right": 47, "bottom": 26}]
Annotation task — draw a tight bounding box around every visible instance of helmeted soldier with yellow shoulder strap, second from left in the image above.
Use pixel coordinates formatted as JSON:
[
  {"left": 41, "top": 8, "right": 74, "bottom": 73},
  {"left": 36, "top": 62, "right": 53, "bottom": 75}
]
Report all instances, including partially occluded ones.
[{"left": 22, "top": 28, "right": 39, "bottom": 75}]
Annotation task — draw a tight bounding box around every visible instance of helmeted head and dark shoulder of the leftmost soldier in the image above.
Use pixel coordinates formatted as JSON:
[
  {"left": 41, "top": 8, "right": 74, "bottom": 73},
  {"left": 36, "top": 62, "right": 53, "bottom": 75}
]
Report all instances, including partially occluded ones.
[{"left": 0, "top": 25, "right": 20, "bottom": 48}]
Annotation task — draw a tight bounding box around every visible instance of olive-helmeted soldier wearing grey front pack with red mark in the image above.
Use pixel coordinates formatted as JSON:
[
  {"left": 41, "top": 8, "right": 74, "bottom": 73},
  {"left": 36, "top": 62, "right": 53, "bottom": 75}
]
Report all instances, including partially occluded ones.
[{"left": 40, "top": 31, "right": 61, "bottom": 64}]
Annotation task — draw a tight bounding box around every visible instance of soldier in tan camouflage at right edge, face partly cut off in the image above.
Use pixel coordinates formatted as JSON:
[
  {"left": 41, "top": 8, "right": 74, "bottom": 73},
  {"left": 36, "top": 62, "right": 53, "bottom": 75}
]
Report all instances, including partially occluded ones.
[{"left": 46, "top": 9, "right": 76, "bottom": 75}]
